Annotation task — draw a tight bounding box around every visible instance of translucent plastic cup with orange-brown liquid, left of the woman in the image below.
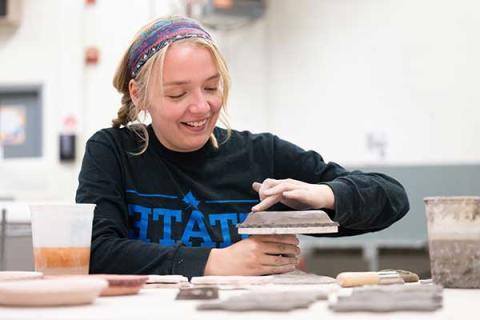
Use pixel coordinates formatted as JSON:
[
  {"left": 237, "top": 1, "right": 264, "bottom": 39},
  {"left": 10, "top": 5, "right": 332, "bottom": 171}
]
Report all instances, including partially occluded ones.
[{"left": 29, "top": 203, "right": 95, "bottom": 275}]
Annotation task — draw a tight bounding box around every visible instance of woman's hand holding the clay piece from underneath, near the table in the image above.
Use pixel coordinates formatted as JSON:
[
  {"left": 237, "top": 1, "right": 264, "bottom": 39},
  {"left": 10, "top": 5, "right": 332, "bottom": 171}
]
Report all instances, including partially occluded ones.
[{"left": 204, "top": 235, "right": 300, "bottom": 276}]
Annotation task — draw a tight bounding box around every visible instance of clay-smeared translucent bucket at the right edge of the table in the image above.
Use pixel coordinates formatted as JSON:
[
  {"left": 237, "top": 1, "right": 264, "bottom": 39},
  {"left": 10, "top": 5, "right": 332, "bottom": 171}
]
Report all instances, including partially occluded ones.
[{"left": 424, "top": 196, "right": 480, "bottom": 288}]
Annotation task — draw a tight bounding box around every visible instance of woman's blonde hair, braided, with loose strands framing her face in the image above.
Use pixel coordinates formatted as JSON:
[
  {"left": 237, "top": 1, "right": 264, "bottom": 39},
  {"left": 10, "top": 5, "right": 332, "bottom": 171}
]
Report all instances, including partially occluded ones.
[{"left": 112, "top": 24, "right": 231, "bottom": 155}]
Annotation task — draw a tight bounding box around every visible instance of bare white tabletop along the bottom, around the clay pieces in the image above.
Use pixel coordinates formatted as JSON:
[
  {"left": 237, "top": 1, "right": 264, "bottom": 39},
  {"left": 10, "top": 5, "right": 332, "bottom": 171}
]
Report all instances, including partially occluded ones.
[{"left": 0, "top": 288, "right": 480, "bottom": 320}]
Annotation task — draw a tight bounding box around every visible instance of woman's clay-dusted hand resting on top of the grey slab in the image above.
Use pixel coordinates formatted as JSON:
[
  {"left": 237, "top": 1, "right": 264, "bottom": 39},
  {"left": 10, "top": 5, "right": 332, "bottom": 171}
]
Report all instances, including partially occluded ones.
[{"left": 252, "top": 179, "right": 335, "bottom": 212}]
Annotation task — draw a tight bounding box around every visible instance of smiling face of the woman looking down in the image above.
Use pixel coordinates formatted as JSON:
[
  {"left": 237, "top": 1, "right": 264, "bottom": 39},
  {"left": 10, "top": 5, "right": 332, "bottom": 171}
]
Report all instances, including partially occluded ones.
[{"left": 147, "top": 42, "right": 222, "bottom": 152}]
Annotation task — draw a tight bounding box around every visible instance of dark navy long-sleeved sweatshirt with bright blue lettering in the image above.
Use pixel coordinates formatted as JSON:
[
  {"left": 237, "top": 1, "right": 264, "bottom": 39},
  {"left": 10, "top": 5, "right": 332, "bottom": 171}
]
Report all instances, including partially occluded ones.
[{"left": 76, "top": 126, "right": 409, "bottom": 277}]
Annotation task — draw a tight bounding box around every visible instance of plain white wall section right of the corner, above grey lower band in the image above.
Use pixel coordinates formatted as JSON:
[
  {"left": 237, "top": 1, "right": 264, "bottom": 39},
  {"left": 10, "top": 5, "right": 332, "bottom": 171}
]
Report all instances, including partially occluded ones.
[{"left": 268, "top": 0, "right": 480, "bottom": 164}]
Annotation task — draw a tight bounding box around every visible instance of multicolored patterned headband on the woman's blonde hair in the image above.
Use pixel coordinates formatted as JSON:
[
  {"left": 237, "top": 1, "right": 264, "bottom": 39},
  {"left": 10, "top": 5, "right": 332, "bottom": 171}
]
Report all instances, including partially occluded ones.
[{"left": 128, "top": 17, "right": 212, "bottom": 79}]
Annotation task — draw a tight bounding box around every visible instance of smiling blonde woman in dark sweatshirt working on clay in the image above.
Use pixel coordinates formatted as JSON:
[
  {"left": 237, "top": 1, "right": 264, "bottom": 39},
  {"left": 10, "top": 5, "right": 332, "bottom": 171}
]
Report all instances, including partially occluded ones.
[{"left": 76, "top": 17, "right": 408, "bottom": 277}]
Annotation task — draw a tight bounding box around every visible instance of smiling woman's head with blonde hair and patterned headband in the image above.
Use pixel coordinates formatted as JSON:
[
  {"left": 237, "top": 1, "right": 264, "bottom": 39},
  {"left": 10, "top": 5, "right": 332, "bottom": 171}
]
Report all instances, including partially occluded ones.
[{"left": 113, "top": 17, "right": 230, "bottom": 153}]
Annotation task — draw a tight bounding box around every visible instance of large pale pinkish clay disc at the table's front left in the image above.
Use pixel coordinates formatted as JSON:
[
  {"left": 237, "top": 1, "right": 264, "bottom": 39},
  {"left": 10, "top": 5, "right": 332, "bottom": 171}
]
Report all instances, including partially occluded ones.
[{"left": 0, "top": 277, "right": 108, "bottom": 306}]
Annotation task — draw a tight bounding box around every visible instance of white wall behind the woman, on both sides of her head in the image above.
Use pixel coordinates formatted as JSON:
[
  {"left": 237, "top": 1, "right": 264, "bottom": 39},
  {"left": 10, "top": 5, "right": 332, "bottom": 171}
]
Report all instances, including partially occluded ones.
[{"left": 0, "top": 0, "right": 480, "bottom": 200}]
